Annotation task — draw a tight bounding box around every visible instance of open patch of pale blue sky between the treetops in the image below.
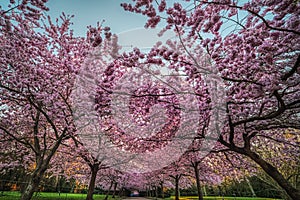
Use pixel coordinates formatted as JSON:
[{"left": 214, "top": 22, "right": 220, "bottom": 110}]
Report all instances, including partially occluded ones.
[{"left": 46, "top": 0, "right": 178, "bottom": 54}]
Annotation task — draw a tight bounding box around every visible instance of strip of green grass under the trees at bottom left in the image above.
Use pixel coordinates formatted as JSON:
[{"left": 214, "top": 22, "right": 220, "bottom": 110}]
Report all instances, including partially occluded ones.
[{"left": 0, "top": 192, "right": 114, "bottom": 200}]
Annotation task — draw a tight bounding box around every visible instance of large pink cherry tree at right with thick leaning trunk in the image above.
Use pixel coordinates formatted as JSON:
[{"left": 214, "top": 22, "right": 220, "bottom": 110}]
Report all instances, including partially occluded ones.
[{"left": 122, "top": 0, "right": 300, "bottom": 199}]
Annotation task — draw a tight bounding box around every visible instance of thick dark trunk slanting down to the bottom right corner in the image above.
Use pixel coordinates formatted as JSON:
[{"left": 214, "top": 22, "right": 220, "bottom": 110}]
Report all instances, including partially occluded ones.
[{"left": 246, "top": 151, "right": 300, "bottom": 200}]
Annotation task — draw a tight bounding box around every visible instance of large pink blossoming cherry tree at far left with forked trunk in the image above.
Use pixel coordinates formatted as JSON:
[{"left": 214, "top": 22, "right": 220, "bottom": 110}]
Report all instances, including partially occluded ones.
[{"left": 0, "top": 1, "right": 109, "bottom": 200}]
